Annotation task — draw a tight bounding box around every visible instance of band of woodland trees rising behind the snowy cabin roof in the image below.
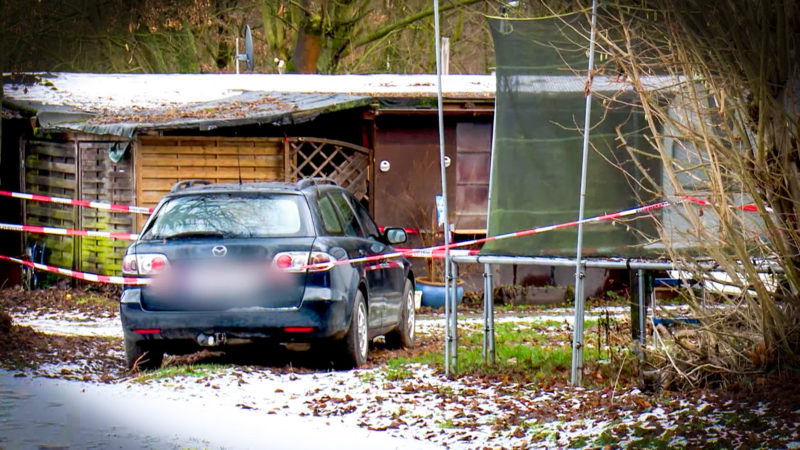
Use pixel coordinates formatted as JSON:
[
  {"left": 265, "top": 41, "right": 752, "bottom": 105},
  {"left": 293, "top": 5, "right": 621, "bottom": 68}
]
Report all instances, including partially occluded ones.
[{"left": 0, "top": 0, "right": 502, "bottom": 73}]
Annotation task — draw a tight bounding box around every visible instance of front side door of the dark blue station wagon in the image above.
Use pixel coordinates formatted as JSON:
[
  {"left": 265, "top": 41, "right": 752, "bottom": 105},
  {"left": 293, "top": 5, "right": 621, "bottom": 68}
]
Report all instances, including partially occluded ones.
[{"left": 348, "top": 196, "right": 406, "bottom": 328}]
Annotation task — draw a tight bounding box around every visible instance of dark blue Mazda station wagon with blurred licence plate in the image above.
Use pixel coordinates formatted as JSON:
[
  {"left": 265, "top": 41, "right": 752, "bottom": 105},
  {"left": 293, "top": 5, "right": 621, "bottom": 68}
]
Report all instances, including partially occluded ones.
[{"left": 120, "top": 179, "right": 415, "bottom": 368}]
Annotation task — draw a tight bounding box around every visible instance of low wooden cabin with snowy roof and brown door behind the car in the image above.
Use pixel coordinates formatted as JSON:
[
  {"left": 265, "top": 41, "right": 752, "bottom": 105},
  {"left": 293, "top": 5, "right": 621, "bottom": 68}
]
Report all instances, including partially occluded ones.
[{"left": 0, "top": 73, "right": 494, "bottom": 281}]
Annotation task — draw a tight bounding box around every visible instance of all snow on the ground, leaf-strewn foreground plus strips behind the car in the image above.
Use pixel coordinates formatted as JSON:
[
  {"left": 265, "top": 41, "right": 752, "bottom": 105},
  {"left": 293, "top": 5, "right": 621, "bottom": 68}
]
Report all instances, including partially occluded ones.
[{"left": 7, "top": 307, "right": 800, "bottom": 448}]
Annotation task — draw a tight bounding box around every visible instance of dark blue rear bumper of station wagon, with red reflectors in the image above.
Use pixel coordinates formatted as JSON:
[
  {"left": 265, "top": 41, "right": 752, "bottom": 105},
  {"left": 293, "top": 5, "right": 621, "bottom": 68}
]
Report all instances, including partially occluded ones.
[{"left": 120, "top": 288, "right": 349, "bottom": 342}]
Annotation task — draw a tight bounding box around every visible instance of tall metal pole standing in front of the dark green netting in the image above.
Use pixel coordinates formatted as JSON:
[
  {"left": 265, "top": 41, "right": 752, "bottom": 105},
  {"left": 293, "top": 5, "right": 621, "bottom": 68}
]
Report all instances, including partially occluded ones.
[{"left": 570, "top": 0, "right": 597, "bottom": 386}]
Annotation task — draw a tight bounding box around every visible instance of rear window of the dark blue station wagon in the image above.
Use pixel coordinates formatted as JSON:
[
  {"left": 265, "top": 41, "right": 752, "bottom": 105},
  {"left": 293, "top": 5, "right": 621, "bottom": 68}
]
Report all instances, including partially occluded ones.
[{"left": 142, "top": 193, "right": 311, "bottom": 239}]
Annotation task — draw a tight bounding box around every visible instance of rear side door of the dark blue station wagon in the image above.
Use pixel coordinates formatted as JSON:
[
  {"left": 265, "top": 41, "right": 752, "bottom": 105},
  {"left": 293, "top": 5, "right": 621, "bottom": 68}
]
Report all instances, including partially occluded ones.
[{"left": 326, "top": 190, "right": 386, "bottom": 329}]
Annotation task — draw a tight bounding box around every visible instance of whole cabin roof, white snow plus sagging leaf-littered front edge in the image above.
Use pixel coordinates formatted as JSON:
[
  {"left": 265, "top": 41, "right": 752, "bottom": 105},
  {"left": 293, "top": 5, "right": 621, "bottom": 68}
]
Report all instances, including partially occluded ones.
[{"left": 4, "top": 73, "right": 494, "bottom": 137}]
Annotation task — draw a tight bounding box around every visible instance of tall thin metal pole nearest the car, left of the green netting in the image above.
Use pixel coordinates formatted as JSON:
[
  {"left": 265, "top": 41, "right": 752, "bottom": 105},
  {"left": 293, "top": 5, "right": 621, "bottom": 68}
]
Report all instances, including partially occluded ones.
[{"left": 433, "top": 0, "right": 457, "bottom": 376}]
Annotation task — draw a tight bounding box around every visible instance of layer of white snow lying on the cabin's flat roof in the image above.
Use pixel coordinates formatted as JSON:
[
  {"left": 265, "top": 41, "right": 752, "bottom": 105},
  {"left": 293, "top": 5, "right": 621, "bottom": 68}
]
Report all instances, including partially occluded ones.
[{"left": 6, "top": 73, "right": 494, "bottom": 112}]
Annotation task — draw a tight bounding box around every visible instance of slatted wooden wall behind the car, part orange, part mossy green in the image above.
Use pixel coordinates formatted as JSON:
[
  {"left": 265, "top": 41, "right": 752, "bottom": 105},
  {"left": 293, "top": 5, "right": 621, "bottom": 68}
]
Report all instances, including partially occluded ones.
[{"left": 20, "top": 135, "right": 370, "bottom": 275}]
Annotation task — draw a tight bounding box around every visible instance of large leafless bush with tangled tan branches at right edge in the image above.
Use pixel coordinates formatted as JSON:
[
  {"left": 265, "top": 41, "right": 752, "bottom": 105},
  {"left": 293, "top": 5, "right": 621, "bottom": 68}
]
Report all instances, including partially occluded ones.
[{"left": 598, "top": 0, "right": 800, "bottom": 383}]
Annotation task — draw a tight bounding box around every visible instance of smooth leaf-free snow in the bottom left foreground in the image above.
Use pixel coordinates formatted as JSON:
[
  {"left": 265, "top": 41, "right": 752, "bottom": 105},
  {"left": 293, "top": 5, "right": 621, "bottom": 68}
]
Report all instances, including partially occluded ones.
[{"left": 0, "top": 370, "right": 434, "bottom": 449}]
